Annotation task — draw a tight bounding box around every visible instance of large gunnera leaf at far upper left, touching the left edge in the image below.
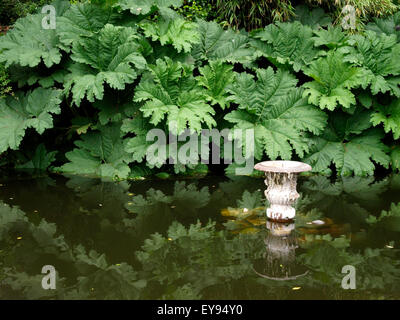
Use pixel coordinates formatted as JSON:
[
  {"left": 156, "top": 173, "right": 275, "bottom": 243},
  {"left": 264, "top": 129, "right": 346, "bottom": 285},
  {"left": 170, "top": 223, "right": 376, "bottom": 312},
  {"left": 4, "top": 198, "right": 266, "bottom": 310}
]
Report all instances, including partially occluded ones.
[{"left": 0, "top": 14, "right": 61, "bottom": 68}]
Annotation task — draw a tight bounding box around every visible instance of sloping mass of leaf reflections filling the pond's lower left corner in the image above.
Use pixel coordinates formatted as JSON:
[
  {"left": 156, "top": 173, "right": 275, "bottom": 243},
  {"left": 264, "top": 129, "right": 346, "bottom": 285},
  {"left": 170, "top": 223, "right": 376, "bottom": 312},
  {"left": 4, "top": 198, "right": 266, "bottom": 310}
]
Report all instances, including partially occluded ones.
[{"left": 0, "top": 203, "right": 146, "bottom": 299}]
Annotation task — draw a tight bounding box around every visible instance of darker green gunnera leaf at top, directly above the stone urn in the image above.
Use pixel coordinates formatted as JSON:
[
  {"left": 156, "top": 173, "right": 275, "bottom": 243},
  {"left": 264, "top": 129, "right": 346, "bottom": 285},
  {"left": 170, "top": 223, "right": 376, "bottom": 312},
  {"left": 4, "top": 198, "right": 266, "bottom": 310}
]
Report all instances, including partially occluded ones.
[{"left": 252, "top": 21, "right": 318, "bottom": 71}]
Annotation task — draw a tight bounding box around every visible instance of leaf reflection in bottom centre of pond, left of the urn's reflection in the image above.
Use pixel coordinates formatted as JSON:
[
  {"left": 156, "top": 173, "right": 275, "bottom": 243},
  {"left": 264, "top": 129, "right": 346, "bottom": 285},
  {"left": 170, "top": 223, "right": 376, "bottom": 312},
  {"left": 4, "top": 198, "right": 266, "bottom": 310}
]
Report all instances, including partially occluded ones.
[{"left": 137, "top": 222, "right": 263, "bottom": 298}]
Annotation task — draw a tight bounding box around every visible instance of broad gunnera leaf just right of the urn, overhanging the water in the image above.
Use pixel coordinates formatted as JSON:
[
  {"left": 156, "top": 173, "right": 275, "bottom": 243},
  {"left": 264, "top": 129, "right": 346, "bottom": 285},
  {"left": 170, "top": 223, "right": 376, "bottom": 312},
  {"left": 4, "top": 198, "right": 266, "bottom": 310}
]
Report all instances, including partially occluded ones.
[{"left": 303, "top": 110, "right": 390, "bottom": 176}]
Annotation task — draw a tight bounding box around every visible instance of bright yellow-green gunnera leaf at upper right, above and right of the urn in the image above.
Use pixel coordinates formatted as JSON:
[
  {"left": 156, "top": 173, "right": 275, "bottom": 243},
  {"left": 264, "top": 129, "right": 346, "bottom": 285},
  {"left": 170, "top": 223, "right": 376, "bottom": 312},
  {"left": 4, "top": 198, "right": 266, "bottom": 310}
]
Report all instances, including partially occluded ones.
[{"left": 303, "top": 51, "right": 366, "bottom": 110}]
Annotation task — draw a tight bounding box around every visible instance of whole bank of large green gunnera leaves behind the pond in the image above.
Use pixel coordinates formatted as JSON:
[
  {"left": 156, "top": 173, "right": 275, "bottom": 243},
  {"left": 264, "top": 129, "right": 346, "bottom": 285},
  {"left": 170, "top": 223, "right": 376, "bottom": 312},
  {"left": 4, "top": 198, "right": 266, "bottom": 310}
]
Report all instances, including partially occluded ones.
[{"left": 0, "top": 0, "right": 400, "bottom": 179}]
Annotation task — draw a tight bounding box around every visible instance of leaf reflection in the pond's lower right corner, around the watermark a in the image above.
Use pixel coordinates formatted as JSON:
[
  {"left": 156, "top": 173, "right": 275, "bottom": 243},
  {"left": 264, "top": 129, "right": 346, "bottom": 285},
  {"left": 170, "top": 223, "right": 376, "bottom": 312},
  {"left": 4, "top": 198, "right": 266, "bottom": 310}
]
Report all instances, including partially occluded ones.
[{"left": 299, "top": 236, "right": 400, "bottom": 298}]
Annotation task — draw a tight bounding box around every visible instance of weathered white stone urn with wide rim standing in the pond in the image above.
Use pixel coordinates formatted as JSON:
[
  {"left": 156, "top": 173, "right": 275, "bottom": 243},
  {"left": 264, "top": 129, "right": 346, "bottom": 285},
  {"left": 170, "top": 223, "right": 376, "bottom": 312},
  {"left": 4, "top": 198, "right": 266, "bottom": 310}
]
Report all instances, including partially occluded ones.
[{"left": 254, "top": 161, "right": 312, "bottom": 222}]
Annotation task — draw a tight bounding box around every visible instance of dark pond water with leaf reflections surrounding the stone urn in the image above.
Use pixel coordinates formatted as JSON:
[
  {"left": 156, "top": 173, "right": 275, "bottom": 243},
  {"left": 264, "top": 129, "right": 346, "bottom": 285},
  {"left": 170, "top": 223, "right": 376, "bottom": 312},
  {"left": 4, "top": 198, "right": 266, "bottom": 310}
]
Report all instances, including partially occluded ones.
[{"left": 0, "top": 174, "right": 400, "bottom": 299}]
